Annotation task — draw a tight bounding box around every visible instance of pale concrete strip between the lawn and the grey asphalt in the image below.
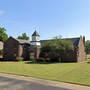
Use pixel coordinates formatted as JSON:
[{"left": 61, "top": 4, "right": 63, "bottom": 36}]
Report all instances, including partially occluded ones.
[{"left": 0, "top": 73, "right": 90, "bottom": 90}]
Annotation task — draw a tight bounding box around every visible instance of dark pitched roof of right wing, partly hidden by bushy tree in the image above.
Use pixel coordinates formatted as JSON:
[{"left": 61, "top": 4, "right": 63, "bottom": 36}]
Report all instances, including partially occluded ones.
[{"left": 40, "top": 37, "right": 80, "bottom": 47}]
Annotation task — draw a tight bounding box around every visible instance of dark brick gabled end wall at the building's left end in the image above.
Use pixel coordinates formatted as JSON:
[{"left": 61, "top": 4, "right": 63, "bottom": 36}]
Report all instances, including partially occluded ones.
[{"left": 3, "top": 38, "right": 19, "bottom": 60}]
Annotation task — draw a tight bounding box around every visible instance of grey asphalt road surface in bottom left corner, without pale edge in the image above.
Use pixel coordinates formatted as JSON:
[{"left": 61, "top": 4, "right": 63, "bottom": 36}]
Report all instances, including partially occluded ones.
[{"left": 0, "top": 76, "right": 70, "bottom": 90}]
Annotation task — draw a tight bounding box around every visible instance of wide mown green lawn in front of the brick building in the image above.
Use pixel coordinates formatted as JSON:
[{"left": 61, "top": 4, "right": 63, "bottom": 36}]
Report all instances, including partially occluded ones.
[{"left": 0, "top": 58, "right": 90, "bottom": 86}]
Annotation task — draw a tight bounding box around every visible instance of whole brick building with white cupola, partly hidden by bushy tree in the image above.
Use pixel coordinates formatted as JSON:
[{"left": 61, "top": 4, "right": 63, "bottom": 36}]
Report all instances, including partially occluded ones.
[{"left": 4, "top": 31, "right": 86, "bottom": 62}]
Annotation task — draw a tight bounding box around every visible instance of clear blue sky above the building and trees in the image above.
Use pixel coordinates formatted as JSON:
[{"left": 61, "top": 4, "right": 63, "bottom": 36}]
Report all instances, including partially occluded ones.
[{"left": 0, "top": 0, "right": 90, "bottom": 40}]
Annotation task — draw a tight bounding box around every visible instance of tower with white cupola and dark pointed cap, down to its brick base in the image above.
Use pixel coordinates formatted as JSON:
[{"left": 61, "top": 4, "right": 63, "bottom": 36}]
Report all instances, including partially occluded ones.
[{"left": 30, "top": 30, "right": 41, "bottom": 60}]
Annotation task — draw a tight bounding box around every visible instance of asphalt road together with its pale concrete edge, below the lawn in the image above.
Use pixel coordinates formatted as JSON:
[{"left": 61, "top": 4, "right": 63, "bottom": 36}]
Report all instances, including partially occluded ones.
[{"left": 0, "top": 73, "right": 90, "bottom": 90}]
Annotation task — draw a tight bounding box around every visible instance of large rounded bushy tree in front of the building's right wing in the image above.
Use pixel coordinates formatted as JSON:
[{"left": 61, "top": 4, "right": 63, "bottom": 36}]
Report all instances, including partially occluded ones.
[{"left": 40, "top": 39, "right": 74, "bottom": 59}]
